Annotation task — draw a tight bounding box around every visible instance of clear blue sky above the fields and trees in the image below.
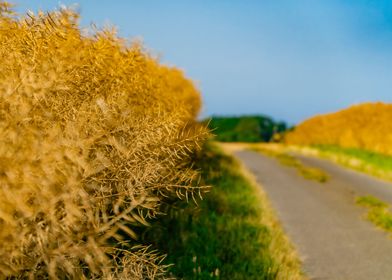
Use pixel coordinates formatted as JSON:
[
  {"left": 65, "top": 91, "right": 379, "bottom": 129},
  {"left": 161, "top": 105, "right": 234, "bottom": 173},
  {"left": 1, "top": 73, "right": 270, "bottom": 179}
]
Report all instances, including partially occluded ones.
[{"left": 14, "top": 0, "right": 392, "bottom": 123}]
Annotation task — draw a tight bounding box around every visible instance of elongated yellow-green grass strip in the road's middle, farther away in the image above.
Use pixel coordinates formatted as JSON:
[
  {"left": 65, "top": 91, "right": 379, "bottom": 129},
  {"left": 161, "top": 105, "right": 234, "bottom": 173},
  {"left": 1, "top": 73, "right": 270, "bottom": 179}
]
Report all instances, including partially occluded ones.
[{"left": 250, "top": 144, "right": 329, "bottom": 183}]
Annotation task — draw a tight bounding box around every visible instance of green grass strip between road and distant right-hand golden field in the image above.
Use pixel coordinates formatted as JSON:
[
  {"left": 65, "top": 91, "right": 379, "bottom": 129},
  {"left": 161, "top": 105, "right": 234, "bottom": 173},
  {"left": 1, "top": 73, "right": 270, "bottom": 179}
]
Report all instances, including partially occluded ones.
[{"left": 289, "top": 145, "right": 392, "bottom": 181}]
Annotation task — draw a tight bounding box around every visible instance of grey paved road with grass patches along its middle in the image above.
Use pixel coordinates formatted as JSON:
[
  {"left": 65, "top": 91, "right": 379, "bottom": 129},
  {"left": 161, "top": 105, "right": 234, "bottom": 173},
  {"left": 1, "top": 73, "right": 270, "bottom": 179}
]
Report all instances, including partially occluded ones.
[{"left": 235, "top": 150, "right": 392, "bottom": 280}]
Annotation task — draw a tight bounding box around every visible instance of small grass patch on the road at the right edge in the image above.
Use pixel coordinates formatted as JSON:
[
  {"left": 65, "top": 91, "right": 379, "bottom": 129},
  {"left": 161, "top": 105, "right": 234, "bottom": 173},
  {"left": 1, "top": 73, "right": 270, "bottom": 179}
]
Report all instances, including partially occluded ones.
[{"left": 356, "top": 195, "right": 392, "bottom": 232}]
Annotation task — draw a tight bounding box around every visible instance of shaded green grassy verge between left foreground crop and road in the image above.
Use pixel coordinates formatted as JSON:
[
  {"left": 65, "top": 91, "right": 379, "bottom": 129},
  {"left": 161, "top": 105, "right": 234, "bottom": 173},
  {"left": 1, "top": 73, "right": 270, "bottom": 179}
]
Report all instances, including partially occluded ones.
[{"left": 147, "top": 145, "right": 303, "bottom": 279}]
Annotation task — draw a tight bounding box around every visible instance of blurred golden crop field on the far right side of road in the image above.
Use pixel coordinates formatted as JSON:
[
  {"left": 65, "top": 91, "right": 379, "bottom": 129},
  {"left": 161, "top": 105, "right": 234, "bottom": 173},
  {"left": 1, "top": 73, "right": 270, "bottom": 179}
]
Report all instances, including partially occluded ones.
[{"left": 285, "top": 103, "right": 392, "bottom": 155}]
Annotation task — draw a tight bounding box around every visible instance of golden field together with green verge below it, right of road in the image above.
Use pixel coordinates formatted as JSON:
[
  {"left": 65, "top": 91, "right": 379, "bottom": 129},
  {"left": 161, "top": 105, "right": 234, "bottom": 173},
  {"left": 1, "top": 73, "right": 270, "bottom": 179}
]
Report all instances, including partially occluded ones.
[{"left": 283, "top": 102, "right": 392, "bottom": 180}]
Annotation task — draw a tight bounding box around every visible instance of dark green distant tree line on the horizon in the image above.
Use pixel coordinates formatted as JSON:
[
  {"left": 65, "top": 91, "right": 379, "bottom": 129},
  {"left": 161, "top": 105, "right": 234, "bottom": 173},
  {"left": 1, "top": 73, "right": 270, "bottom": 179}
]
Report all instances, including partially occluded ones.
[{"left": 205, "top": 115, "right": 287, "bottom": 142}]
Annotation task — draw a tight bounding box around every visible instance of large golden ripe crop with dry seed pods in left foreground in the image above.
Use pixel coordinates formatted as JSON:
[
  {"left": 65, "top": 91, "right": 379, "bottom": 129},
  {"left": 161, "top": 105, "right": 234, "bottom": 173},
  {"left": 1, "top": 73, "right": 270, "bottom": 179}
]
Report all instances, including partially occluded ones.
[{"left": 0, "top": 2, "right": 208, "bottom": 279}]
